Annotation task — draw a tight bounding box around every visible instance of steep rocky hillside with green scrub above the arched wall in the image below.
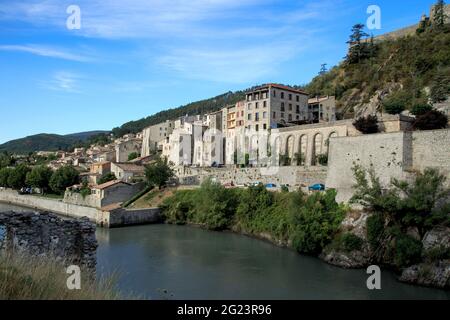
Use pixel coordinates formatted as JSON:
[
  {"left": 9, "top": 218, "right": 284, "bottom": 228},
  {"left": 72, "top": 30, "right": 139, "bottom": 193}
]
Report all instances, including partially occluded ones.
[{"left": 304, "top": 24, "right": 450, "bottom": 118}]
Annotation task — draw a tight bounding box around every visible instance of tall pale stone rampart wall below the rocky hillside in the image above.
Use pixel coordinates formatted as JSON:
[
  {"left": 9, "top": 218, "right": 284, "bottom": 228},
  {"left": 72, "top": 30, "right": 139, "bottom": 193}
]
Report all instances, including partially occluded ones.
[{"left": 326, "top": 129, "right": 450, "bottom": 201}]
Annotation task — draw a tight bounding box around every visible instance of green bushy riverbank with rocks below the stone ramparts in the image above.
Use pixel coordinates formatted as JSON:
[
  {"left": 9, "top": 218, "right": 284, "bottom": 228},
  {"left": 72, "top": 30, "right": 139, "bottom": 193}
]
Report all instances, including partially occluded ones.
[{"left": 158, "top": 171, "right": 450, "bottom": 289}]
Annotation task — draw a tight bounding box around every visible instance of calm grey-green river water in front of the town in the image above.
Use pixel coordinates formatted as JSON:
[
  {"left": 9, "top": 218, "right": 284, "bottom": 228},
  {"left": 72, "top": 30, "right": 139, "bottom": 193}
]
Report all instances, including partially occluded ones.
[{"left": 0, "top": 204, "right": 450, "bottom": 300}]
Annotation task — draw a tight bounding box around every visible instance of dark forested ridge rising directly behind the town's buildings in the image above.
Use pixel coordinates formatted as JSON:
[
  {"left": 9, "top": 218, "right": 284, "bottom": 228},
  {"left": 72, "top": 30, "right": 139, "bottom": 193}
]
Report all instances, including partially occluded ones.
[{"left": 112, "top": 91, "right": 245, "bottom": 137}]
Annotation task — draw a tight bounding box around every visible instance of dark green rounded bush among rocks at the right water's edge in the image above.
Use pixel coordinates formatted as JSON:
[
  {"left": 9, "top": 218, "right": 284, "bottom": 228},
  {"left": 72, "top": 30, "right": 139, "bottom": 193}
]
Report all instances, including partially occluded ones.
[{"left": 394, "top": 234, "right": 422, "bottom": 268}]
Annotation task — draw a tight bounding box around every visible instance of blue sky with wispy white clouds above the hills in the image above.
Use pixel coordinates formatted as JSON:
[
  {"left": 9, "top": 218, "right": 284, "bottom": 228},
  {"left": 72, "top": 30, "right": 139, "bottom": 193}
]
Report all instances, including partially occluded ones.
[{"left": 0, "top": 0, "right": 435, "bottom": 143}]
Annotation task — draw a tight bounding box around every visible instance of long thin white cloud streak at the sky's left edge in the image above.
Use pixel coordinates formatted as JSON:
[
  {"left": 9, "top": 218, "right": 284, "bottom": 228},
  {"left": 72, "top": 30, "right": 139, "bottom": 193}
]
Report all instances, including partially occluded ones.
[{"left": 0, "top": 44, "right": 92, "bottom": 62}]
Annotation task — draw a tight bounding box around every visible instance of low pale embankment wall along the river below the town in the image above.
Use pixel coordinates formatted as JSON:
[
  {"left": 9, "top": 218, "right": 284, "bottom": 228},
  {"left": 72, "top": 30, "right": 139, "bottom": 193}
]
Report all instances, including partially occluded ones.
[{"left": 0, "top": 189, "right": 160, "bottom": 228}]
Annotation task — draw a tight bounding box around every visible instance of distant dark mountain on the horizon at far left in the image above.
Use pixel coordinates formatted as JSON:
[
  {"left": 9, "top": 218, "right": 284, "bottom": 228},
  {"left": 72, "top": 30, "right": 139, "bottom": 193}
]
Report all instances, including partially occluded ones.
[{"left": 0, "top": 131, "right": 109, "bottom": 154}]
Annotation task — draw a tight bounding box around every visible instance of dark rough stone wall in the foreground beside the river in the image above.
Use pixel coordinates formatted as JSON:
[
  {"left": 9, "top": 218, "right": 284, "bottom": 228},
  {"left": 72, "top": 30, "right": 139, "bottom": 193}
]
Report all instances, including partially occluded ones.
[{"left": 0, "top": 212, "right": 97, "bottom": 272}]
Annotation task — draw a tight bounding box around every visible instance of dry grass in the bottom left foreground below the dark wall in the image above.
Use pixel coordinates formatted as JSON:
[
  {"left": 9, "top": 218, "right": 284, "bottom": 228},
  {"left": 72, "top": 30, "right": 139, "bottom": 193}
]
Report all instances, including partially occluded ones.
[{"left": 0, "top": 253, "right": 130, "bottom": 300}]
